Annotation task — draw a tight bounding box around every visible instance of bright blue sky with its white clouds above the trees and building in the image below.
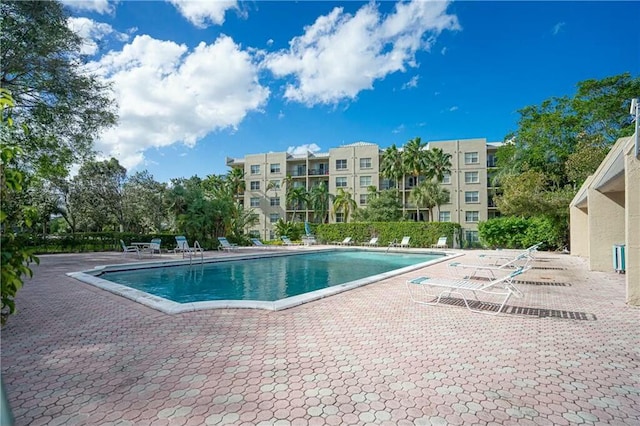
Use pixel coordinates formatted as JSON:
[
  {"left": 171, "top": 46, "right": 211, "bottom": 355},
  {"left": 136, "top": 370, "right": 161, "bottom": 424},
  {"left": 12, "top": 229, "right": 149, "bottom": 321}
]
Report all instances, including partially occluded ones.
[{"left": 63, "top": 0, "right": 640, "bottom": 181}]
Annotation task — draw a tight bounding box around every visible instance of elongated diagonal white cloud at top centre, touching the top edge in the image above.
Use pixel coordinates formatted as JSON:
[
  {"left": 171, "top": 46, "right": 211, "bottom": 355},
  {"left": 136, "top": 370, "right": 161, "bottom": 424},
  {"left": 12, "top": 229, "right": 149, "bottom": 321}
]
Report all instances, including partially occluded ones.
[{"left": 263, "top": 0, "right": 460, "bottom": 106}]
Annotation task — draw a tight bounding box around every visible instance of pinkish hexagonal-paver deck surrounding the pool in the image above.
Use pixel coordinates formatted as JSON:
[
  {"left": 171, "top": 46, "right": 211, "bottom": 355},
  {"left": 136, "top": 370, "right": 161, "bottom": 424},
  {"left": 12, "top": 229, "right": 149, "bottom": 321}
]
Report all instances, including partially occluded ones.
[{"left": 1, "top": 248, "right": 640, "bottom": 425}]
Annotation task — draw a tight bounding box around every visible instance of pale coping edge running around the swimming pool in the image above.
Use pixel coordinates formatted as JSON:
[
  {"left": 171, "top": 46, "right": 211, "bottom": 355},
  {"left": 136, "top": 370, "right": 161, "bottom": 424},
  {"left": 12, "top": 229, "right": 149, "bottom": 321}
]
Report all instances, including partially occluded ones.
[{"left": 66, "top": 247, "right": 464, "bottom": 314}]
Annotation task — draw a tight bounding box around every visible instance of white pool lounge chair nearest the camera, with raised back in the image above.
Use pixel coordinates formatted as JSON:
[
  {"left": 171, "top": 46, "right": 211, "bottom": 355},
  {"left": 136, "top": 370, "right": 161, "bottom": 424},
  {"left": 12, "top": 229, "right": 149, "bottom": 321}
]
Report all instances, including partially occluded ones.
[{"left": 406, "top": 266, "right": 529, "bottom": 315}]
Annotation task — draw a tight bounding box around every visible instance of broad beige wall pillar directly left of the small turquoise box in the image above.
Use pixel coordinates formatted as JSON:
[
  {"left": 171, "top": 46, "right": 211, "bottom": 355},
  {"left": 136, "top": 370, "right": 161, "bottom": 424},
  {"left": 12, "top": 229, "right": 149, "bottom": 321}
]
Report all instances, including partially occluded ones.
[{"left": 587, "top": 188, "right": 625, "bottom": 272}]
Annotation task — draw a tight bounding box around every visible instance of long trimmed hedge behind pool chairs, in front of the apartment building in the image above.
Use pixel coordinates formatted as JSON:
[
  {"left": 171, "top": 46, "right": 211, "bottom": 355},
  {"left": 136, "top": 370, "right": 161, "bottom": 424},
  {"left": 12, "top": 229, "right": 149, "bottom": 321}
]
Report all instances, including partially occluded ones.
[{"left": 315, "top": 222, "right": 461, "bottom": 247}]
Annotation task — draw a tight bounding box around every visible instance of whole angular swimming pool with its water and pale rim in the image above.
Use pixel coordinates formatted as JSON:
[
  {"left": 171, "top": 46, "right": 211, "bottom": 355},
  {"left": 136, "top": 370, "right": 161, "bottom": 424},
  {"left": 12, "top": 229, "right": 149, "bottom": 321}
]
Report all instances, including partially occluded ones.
[{"left": 69, "top": 249, "right": 452, "bottom": 313}]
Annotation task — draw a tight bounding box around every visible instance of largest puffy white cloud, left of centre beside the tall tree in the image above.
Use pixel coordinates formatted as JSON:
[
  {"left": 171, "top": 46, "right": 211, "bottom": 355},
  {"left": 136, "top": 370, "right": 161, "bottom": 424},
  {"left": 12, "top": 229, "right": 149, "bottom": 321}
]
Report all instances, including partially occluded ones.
[{"left": 88, "top": 35, "right": 269, "bottom": 168}]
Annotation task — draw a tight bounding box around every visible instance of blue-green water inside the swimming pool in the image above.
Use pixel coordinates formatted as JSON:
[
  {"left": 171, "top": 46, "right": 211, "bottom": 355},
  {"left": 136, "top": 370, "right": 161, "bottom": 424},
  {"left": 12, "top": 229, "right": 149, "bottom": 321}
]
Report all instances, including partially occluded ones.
[{"left": 100, "top": 250, "right": 441, "bottom": 303}]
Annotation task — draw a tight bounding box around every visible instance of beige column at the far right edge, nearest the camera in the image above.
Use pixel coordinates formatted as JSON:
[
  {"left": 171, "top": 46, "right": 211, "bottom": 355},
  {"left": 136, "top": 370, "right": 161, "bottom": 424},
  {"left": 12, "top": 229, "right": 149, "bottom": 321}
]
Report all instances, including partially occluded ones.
[{"left": 624, "top": 146, "right": 640, "bottom": 306}]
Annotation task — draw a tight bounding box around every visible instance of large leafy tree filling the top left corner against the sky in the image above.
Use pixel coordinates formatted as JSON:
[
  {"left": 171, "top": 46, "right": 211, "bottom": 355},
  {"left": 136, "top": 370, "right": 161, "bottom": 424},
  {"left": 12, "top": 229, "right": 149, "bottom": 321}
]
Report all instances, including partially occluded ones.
[{"left": 0, "top": 1, "right": 117, "bottom": 177}]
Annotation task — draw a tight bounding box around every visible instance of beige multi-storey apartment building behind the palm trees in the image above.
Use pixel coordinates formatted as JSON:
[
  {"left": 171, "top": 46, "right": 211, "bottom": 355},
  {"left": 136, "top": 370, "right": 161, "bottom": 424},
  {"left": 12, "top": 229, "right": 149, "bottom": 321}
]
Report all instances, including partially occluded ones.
[{"left": 227, "top": 139, "right": 502, "bottom": 242}]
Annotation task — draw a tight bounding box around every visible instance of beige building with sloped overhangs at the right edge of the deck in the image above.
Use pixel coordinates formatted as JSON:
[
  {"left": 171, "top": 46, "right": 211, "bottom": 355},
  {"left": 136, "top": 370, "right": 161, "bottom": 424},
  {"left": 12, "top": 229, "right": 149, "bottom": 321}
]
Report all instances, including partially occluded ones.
[{"left": 570, "top": 135, "right": 640, "bottom": 306}]
